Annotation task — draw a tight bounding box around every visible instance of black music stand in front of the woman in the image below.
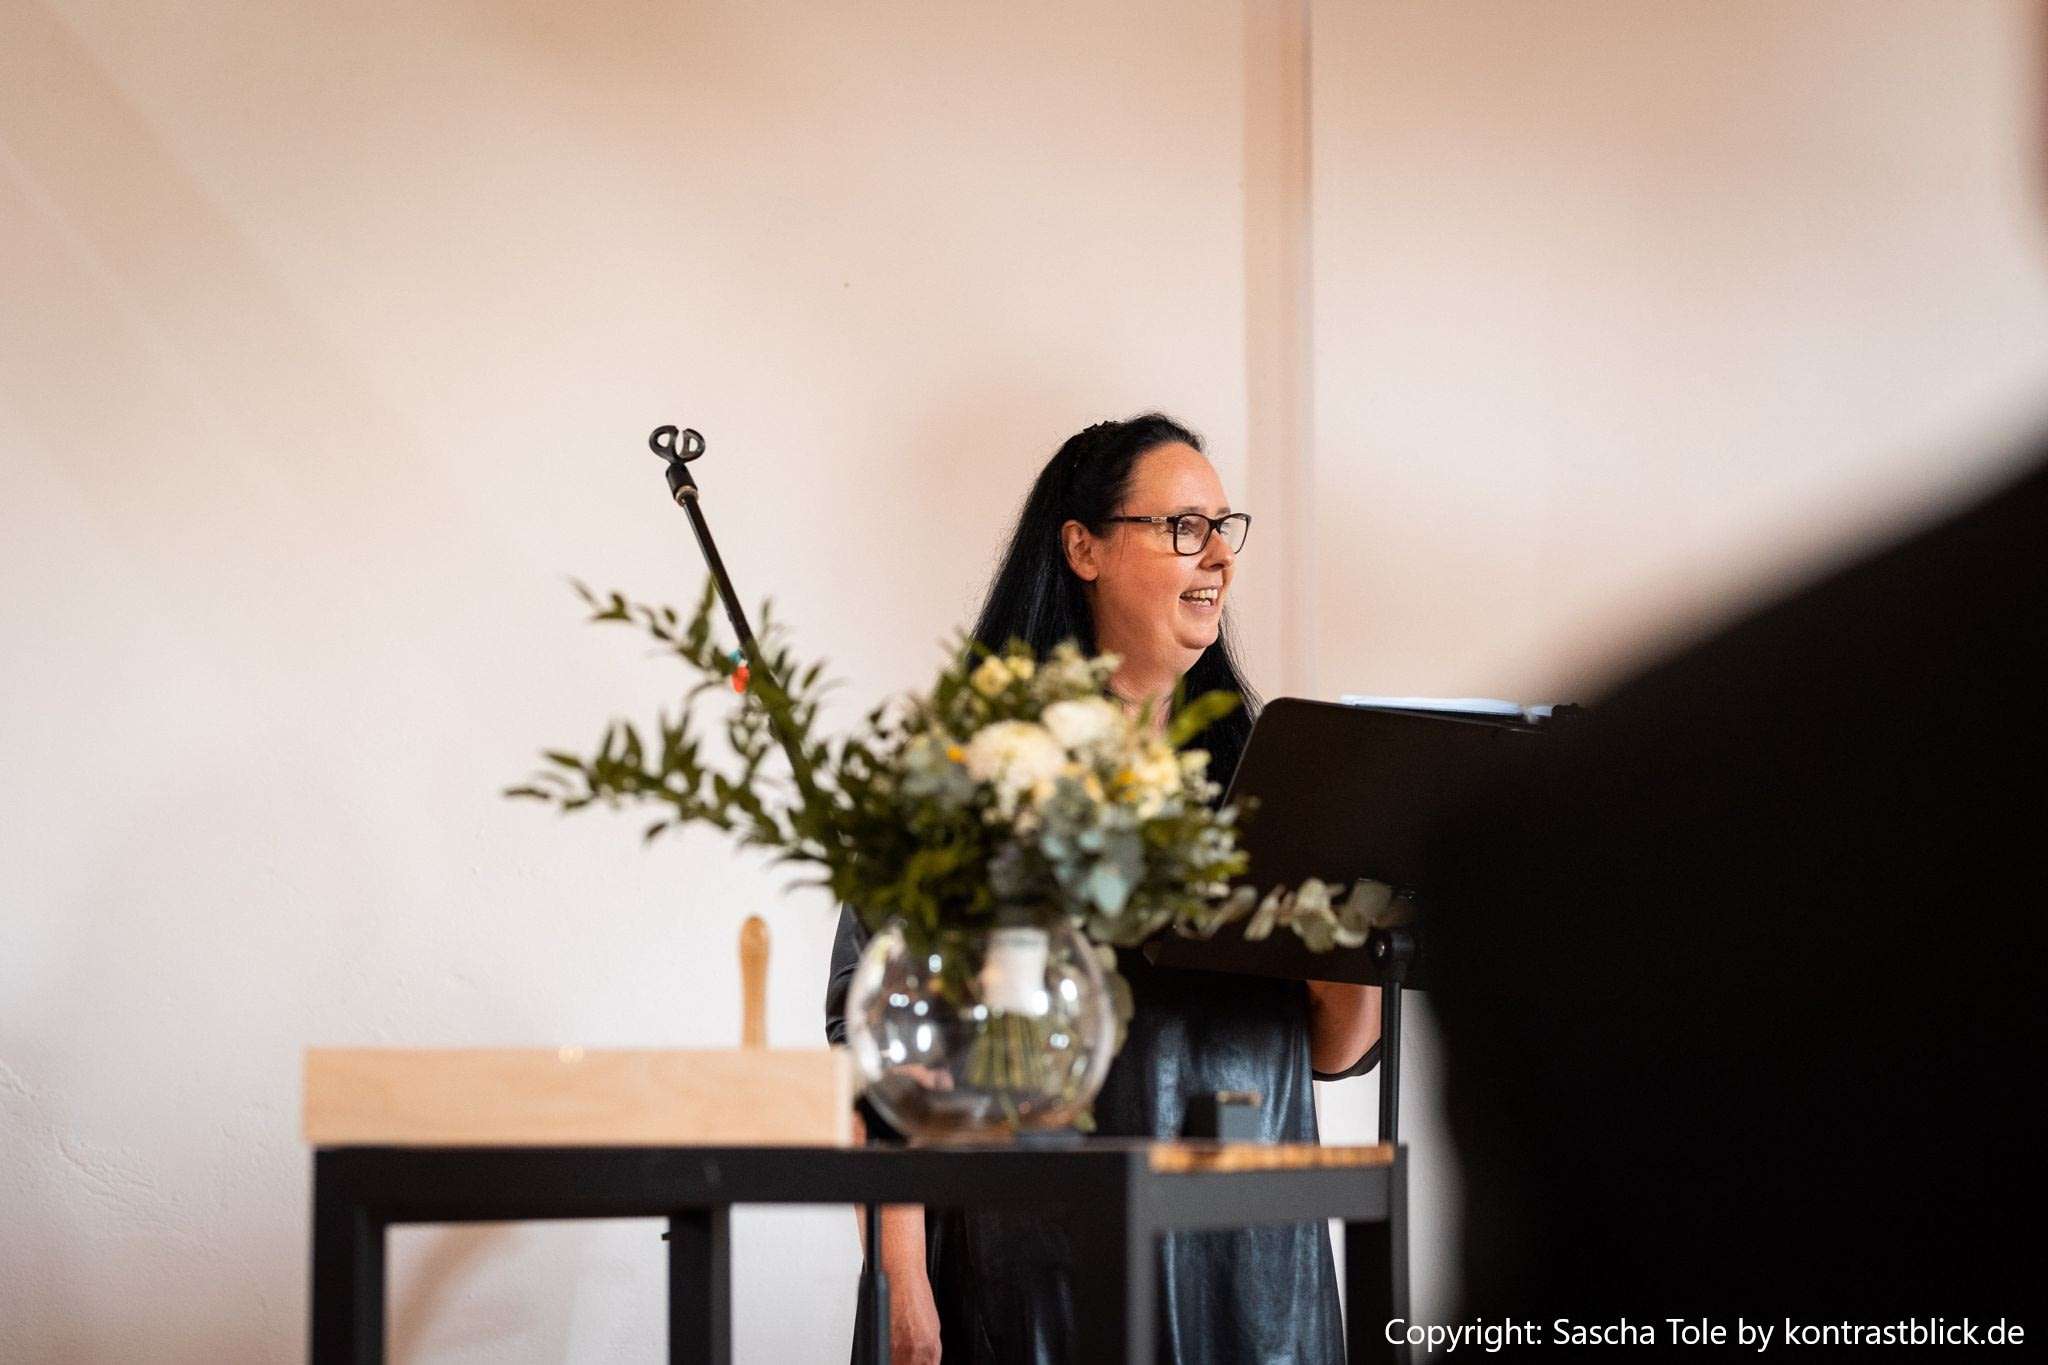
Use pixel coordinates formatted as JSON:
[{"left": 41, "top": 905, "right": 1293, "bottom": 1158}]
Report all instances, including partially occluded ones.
[{"left": 1145, "top": 698, "right": 1577, "bottom": 1142}]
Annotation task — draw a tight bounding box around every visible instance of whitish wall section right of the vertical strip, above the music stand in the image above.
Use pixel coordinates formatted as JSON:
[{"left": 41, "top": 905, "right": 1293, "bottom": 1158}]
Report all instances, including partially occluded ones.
[{"left": 1313, "top": 0, "right": 2048, "bottom": 698}]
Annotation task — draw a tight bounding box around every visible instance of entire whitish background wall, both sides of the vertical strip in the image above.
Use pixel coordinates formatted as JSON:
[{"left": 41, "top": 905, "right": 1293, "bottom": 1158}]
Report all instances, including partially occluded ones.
[{"left": 0, "top": 0, "right": 2048, "bottom": 1361}]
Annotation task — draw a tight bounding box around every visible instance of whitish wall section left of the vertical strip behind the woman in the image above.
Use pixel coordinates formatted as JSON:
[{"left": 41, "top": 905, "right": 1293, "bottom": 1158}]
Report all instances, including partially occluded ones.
[{"left": 0, "top": 0, "right": 1245, "bottom": 1363}]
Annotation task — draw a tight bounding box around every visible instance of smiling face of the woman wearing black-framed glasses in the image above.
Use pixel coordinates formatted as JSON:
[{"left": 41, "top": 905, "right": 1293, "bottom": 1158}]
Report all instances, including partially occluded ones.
[{"left": 1065, "top": 442, "right": 1237, "bottom": 675}]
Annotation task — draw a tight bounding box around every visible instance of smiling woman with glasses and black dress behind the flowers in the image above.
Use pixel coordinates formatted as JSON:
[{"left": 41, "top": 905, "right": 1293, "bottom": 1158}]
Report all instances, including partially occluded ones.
[{"left": 825, "top": 413, "right": 1378, "bottom": 1365}]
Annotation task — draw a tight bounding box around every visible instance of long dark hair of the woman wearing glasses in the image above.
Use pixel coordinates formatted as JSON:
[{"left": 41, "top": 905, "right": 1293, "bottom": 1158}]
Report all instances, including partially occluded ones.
[{"left": 975, "top": 413, "right": 1257, "bottom": 786}]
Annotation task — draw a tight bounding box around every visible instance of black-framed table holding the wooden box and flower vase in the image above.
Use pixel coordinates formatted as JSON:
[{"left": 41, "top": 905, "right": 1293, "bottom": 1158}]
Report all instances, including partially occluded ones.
[{"left": 311, "top": 1140, "right": 1407, "bottom": 1365}]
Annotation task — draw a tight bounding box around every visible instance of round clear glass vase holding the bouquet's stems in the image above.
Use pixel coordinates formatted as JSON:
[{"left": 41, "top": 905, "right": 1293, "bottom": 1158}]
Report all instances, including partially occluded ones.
[{"left": 846, "top": 913, "right": 1116, "bottom": 1142}]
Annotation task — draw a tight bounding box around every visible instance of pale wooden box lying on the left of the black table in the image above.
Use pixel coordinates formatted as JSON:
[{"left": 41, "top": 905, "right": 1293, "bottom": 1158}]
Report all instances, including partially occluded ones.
[{"left": 305, "top": 1048, "right": 854, "bottom": 1146}]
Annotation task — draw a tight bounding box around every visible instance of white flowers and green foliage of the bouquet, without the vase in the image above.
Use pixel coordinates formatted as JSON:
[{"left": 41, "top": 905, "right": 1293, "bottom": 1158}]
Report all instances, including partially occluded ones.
[{"left": 506, "top": 581, "right": 1384, "bottom": 965}]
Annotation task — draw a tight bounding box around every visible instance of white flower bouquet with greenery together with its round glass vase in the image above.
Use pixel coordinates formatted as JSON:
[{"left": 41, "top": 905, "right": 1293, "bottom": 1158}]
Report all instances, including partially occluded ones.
[{"left": 508, "top": 583, "right": 1382, "bottom": 1136}]
